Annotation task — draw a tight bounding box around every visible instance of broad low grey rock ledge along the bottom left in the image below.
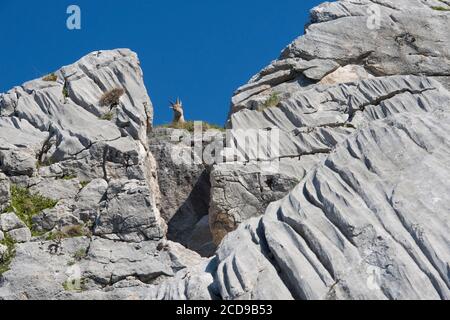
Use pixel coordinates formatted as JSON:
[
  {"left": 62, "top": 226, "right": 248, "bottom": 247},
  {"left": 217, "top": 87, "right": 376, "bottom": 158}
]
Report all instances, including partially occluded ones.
[{"left": 0, "top": 237, "right": 217, "bottom": 300}]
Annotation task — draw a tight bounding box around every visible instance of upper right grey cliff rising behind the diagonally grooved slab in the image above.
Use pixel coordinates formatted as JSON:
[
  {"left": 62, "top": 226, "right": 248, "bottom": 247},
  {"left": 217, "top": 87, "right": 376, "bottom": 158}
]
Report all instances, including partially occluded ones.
[{"left": 210, "top": 0, "right": 450, "bottom": 243}]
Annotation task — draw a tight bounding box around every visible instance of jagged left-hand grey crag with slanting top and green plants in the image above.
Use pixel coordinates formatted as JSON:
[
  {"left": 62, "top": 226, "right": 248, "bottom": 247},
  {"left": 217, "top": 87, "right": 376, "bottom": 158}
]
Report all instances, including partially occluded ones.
[{"left": 0, "top": 50, "right": 216, "bottom": 299}]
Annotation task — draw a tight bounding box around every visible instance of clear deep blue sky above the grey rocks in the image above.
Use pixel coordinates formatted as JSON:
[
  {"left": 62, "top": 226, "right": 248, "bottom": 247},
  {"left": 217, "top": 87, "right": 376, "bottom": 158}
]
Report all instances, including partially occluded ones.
[{"left": 0, "top": 0, "right": 322, "bottom": 124}]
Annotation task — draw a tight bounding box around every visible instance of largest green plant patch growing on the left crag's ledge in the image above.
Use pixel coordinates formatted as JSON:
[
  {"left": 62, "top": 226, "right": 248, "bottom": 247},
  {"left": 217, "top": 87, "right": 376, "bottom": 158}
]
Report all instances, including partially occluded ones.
[{"left": 5, "top": 185, "right": 58, "bottom": 229}]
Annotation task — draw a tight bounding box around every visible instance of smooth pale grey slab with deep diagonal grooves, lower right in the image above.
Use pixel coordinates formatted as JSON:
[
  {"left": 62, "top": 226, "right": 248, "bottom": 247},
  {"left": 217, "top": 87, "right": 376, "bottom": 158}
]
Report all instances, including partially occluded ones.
[{"left": 212, "top": 111, "right": 450, "bottom": 299}]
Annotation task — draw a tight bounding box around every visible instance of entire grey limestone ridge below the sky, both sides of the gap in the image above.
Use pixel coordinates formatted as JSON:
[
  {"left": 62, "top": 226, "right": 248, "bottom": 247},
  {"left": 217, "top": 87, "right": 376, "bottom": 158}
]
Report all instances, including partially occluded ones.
[{"left": 0, "top": 0, "right": 450, "bottom": 300}]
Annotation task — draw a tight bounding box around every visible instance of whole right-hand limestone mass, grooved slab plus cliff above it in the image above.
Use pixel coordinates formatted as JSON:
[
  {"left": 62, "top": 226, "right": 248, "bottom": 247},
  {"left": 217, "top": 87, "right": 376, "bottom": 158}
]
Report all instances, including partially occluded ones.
[{"left": 205, "top": 1, "right": 450, "bottom": 299}]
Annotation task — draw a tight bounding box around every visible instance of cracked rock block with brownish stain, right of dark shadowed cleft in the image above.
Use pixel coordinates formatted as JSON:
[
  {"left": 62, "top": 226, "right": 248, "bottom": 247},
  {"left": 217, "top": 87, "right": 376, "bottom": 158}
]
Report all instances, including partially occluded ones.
[{"left": 209, "top": 157, "right": 315, "bottom": 245}]
